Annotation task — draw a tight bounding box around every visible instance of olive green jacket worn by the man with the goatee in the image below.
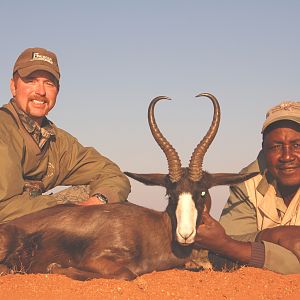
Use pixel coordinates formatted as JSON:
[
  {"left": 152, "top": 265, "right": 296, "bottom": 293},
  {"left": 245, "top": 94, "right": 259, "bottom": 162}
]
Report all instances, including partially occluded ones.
[{"left": 0, "top": 103, "right": 130, "bottom": 223}]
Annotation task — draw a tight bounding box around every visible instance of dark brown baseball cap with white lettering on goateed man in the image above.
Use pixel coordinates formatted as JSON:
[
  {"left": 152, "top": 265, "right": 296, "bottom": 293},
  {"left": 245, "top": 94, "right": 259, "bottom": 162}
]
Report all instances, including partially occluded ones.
[{"left": 13, "top": 48, "right": 60, "bottom": 81}]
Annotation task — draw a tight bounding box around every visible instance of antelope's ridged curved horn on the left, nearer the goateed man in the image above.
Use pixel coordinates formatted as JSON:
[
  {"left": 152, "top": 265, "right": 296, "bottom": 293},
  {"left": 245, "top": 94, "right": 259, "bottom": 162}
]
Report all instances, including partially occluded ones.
[{"left": 148, "top": 96, "right": 183, "bottom": 182}]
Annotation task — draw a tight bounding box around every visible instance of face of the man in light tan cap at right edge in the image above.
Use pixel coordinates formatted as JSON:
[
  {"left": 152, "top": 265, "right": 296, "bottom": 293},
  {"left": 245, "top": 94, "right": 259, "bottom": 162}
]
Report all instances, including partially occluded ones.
[{"left": 263, "top": 121, "right": 300, "bottom": 187}]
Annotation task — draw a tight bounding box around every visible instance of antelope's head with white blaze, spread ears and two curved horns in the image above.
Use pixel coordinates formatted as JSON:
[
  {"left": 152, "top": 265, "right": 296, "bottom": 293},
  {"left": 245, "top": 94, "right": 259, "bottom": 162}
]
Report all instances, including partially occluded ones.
[{"left": 125, "top": 93, "right": 257, "bottom": 246}]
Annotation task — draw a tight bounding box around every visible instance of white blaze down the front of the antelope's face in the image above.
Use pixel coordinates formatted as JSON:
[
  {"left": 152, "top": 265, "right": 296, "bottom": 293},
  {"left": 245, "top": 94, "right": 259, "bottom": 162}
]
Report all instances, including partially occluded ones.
[{"left": 176, "top": 193, "right": 198, "bottom": 245}]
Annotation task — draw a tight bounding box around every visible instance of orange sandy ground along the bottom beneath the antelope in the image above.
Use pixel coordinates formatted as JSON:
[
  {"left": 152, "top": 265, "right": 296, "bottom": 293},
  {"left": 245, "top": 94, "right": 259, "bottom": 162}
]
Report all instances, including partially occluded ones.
[{"left": 0, "top": 267, "right": 300, "bottom": 300}]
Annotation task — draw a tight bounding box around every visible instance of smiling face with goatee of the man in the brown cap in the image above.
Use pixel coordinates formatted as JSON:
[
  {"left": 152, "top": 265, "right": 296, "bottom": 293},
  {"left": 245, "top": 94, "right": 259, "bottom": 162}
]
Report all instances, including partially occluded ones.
[{"left": 10, "top": 71, "right": 58, "bottom": 124}]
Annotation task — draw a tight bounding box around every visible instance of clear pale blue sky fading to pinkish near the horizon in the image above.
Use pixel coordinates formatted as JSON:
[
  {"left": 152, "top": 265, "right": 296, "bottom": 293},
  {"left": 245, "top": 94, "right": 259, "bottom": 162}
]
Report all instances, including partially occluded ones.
[{"left": 0, "top": 0, "right": 300, "bottom": 217}]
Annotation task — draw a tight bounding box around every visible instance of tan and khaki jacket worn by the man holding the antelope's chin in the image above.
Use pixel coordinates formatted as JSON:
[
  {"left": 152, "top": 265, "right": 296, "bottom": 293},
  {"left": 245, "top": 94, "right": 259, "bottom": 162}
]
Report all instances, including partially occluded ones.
[{"left": 220, "top": 154, "right": 300, "bottom": 274}]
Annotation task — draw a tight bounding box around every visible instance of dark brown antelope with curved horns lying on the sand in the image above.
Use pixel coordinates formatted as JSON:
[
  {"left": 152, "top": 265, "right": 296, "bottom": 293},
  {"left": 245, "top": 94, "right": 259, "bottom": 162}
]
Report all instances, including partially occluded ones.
[{"left": 0, "top": 93, "right": 256, "bottom": 280}]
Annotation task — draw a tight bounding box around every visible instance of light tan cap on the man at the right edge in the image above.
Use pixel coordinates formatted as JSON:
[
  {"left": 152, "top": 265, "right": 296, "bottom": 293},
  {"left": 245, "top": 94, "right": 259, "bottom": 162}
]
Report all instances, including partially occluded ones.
[{"left": 261, "top": 101, "right": 300, "bottom": 133}]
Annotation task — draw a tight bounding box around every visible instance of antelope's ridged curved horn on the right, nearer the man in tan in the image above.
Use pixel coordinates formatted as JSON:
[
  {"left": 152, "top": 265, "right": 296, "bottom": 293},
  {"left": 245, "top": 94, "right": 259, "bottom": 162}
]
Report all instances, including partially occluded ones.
[{"left": 189, "top": 93, "right": 221, "bottom": 181}]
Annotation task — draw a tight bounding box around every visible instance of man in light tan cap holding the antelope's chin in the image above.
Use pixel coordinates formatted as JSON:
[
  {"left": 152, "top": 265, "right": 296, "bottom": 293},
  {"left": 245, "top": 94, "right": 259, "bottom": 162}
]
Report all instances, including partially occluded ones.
[{"left": 197, "top": 102, "right": 300, "bottom": 274}]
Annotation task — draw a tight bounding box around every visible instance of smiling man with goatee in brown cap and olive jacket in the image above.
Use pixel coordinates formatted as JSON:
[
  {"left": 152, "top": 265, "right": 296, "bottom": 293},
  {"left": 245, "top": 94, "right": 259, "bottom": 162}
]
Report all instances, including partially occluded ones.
[{"left": 0, "top": 48, "right": 130, "bottom": 223}]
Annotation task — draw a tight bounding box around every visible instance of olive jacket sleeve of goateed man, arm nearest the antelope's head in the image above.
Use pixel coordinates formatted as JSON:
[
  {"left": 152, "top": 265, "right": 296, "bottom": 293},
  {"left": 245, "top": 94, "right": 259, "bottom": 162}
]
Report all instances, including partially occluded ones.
[{"left": 50, "top": 129, "right": 130, "bottom": 202}]
